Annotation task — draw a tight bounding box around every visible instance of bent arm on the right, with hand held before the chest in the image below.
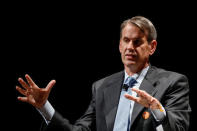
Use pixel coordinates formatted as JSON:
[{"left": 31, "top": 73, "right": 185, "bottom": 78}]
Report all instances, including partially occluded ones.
[{"left": 125, "top": 75, "right": 191, "bottom": 131}]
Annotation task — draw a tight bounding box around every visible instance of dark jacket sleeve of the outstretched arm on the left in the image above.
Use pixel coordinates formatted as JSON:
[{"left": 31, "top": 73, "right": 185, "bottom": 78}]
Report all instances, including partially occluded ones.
[{"left": 41, "top": 86, "right": 96, "bottom": 131}]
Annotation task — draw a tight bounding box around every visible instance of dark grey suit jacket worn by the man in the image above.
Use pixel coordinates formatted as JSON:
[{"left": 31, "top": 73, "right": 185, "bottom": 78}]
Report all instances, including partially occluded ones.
[{"left": 42, "top": 66, "right": 191, "bottom": 131}]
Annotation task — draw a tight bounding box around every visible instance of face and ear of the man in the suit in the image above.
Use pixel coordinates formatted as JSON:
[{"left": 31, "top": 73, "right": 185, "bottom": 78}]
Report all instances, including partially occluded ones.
[{"left": 119, "top": 24, "right": 157, "bottom": 70}]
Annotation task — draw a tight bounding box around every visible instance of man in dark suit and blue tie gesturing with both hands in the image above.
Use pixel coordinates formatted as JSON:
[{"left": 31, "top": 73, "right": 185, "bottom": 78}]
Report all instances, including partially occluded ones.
[{"left": 16, "top": 16, "right": 191, "bottom": 131}]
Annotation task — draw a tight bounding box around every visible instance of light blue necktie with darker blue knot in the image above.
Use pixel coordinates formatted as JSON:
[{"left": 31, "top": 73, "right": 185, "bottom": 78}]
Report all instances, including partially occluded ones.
[{"left": 113, "top": 77, "right": 137, "bottom": 131}]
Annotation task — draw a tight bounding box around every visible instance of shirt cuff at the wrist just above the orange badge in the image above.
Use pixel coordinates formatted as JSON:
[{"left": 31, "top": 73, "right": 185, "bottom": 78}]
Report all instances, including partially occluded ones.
[{"left": 151, "top": 105, "right": 166, "bottom": 122}]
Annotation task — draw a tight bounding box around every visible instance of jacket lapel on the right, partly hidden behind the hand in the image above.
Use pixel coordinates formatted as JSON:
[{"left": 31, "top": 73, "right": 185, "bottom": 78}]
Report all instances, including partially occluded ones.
[{"left": 131, "top": 67, "right": 159, "bottom": 126}]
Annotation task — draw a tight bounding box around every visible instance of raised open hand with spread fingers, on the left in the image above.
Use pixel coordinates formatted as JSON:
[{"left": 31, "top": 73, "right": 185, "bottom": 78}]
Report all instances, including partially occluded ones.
[{"left": 16, "top": 75, "right": 56, "bottom": 108}]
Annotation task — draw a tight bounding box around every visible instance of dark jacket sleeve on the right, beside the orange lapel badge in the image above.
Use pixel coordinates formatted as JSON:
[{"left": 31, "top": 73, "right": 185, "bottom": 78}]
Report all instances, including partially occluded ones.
[{"left": 162, "top": 75, "right": 191, "bottom": 131}]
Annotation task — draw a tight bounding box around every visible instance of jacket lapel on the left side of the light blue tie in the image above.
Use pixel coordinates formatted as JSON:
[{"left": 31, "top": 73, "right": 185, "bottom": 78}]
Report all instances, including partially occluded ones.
[{"left": 103, "top": 72, "right": 124, "bottom": 131}]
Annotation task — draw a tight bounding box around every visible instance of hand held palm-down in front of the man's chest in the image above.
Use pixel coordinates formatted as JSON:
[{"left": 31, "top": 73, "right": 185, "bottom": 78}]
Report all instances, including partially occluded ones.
[{"left": 125, "top": 88, "right": 163, "bottom": 112}]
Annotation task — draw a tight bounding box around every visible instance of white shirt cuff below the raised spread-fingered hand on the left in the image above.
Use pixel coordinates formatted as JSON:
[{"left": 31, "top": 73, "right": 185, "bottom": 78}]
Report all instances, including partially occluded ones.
[{"left": 36, "top": 101, "right": 55, "bottom": 124}]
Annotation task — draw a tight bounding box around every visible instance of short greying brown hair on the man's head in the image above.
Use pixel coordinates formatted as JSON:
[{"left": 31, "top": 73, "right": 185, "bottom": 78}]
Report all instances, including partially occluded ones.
[{"left": 120, "top": 16, "right": 157, "bottom": 42}]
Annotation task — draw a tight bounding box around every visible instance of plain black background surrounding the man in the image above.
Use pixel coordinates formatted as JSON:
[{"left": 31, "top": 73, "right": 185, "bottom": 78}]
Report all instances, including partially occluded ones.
[{"left": 0, "top": 1, "right": 196, "bottom": 131}]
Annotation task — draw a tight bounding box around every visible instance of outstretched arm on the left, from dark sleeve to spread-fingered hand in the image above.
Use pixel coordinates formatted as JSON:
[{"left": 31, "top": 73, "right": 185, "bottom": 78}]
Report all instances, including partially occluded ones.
[{"left": 16, "top": 75, "right": 95, "bottom": 131}]
